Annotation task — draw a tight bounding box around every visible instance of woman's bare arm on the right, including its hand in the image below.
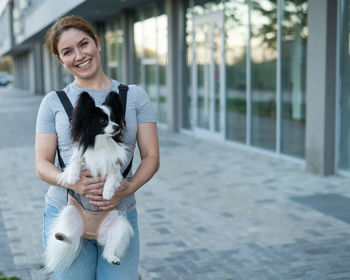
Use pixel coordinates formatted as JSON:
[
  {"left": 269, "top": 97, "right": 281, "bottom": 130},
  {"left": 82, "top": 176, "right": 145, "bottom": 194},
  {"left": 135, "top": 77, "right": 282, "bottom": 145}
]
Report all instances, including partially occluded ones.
[{"left": 90, "top": 123, "right": 160, "bottom": 210}]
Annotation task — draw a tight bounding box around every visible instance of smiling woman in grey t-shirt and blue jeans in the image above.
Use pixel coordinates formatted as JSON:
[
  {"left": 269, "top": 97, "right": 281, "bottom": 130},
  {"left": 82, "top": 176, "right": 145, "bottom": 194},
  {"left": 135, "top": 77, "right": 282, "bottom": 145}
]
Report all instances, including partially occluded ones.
[{"left": 35, "top": 16, "right": 159, "bottom": 280}]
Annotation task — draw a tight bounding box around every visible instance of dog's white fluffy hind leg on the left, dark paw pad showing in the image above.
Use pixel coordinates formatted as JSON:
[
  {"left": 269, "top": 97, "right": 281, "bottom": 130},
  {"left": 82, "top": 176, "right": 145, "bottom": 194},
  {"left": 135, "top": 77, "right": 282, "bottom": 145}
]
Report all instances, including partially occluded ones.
[{"left": 45, "top": 205, "right": 84, "bottom": 272}]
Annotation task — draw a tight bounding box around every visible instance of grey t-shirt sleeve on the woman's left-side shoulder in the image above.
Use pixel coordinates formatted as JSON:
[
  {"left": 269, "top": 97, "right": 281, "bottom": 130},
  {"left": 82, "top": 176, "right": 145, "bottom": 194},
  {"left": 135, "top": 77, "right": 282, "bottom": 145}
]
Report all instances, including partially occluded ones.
[{"left": 36, "top": 94, "right": 56, "bottom": 134}]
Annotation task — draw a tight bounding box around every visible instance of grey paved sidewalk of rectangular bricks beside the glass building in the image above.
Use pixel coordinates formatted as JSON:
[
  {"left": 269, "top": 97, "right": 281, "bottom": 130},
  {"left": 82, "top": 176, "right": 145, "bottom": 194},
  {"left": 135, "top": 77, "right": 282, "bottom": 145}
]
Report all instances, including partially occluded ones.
[{"left": 0, "top": 88, "right": 350, "bottom": 280}]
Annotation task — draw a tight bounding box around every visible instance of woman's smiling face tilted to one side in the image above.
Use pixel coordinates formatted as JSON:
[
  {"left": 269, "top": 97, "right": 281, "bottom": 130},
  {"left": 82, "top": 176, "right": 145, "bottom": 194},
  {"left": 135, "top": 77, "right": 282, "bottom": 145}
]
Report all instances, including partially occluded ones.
[{"left": 57, "top": 28, "right": 101, "bottom": 79}]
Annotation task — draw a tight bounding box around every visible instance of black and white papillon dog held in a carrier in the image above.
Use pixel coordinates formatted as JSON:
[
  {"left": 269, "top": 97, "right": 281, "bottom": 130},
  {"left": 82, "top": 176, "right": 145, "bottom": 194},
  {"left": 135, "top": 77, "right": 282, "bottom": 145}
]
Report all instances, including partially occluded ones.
[{"left": 46, "top": 92, "right": 134, "bottom": 271}]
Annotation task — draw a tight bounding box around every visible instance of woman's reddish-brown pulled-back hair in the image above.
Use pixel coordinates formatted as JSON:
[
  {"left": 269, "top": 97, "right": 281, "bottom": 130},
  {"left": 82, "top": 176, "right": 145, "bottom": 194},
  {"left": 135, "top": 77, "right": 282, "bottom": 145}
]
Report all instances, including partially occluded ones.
[{"left": 44, "top": 16, "right": 97, "bottom": 60}]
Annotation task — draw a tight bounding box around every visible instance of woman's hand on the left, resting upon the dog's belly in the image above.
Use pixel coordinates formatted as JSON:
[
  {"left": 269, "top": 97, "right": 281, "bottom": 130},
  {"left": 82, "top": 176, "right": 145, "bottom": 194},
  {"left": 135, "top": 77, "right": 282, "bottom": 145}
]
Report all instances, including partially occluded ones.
[{"left": 68, "top": 170, "right": 105, "bottom": 196}]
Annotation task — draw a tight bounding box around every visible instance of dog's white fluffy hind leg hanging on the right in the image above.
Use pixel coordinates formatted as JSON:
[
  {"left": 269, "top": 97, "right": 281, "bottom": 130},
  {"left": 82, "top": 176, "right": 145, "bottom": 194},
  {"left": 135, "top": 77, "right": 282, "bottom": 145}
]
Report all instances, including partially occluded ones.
[{"left": 97, "top": 210, "right": 134, "bottom": 264}]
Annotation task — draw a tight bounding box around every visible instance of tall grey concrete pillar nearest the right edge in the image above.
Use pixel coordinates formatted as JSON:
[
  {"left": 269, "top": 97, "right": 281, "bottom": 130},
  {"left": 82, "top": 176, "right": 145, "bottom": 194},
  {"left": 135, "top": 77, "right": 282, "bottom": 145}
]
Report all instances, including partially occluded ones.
[{"left": 306, "top": 0, "right": 337, "bottom": 175}]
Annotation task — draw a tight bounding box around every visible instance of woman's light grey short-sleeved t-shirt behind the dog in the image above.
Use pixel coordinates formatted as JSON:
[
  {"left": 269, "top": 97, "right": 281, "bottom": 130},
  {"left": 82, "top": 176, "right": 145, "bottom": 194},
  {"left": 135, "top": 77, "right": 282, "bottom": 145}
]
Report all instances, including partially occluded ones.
[{"left": 36, "top": 80, "right": 156, "bottom": 212}]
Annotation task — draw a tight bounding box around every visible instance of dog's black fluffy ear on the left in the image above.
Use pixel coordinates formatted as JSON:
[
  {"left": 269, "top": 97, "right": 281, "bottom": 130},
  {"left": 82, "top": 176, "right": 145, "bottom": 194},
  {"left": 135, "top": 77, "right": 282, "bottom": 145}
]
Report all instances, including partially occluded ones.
[{"left": 71, "top": 91, "right": 96, "bottom": 142}]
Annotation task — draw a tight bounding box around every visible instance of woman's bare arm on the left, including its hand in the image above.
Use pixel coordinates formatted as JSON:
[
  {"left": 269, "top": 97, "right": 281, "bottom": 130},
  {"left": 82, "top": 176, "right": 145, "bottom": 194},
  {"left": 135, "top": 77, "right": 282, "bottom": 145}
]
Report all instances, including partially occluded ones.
[{"left": 35, "top": 133, "right": 104, "bottom": 195}]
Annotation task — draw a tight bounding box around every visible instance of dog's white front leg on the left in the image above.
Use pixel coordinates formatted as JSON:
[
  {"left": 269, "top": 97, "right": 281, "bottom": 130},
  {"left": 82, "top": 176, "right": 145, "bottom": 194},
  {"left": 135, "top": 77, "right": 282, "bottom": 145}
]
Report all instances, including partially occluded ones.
[{"left": 58, "top": 148, "right": 82, "bottom": 186}]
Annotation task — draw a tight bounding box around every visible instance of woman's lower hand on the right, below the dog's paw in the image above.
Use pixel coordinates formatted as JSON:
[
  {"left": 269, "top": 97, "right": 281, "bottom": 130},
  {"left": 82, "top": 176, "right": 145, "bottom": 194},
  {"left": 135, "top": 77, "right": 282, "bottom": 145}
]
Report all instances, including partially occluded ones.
[{"left": 86, "top": 180, "right": 131, "bottom": 211}]
